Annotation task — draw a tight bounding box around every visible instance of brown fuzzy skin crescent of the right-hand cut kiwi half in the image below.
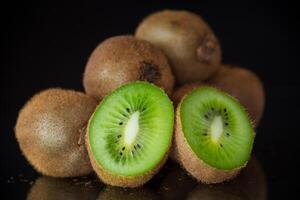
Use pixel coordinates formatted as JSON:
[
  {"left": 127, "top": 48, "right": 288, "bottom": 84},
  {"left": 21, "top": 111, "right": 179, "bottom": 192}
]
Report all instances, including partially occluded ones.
[{"left": 174, "top": 103, "right": 243, "bottom": 184}]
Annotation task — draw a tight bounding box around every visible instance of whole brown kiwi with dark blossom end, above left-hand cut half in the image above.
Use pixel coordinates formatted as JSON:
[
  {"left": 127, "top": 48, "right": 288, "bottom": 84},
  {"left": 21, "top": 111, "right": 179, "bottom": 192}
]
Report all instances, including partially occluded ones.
[{"left": 83, "top": 35, "right": 174, "bottom": 99}]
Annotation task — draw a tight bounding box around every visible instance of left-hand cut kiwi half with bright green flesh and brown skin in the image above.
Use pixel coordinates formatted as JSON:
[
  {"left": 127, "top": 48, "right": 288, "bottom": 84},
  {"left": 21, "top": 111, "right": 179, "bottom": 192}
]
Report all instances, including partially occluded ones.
[{"left": 86, "top": 81, "right": 174, "bottom": 187}]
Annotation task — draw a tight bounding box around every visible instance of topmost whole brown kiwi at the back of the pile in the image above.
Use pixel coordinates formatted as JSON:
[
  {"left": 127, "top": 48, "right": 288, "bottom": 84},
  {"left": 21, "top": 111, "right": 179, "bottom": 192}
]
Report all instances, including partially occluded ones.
[{"left": 135, "top": 10, "right": 222, "bottom": 85}]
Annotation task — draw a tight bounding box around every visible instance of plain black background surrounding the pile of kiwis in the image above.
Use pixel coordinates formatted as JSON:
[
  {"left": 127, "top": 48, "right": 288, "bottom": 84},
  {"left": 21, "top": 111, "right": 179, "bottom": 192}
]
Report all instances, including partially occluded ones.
[{"left": 0, "top": 0, "right": 300, "bottom": 199}]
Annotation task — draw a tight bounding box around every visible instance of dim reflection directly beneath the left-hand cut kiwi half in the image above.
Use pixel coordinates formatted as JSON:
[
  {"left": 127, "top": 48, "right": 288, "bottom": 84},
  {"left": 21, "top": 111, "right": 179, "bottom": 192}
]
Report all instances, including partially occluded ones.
[{"left": 97, "top": 186, "right": 159, "bottom": 200}]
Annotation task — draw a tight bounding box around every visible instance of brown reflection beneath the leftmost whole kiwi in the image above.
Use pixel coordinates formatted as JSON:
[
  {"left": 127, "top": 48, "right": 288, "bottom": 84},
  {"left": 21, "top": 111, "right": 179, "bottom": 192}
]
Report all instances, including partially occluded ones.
[{"left": 27, "top": 176, "right": 98, "bottom": 200}]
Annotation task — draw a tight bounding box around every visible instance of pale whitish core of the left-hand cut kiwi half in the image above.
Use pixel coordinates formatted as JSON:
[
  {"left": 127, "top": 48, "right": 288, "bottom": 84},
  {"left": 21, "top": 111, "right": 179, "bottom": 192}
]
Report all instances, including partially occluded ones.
[{"left": 124, "top": 111, "right": 140, "bottom": 146}]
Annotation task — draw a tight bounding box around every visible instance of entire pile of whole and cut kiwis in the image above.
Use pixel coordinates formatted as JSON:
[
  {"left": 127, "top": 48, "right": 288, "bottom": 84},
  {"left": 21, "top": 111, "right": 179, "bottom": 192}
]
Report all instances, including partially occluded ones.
[{"left": 15, "top": 10, "right": 264, "bottom": 187}]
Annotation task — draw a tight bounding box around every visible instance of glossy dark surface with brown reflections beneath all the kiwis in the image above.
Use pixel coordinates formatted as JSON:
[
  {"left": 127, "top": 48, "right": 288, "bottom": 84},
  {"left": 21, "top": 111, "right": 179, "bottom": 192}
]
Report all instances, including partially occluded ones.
[{"left": 2, "top": 156, "right": 268, "bottom": 200}]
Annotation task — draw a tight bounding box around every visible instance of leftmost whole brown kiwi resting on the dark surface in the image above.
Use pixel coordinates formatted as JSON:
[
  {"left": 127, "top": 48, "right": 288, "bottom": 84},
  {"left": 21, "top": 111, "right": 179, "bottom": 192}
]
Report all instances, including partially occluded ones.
[{"left": 15, "top": 88, "right": 97, "bottom": 177}]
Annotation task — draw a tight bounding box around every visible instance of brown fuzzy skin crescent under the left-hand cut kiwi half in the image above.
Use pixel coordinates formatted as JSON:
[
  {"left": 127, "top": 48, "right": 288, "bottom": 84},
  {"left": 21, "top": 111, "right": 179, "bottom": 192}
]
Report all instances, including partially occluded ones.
[{"left": 86, "top": 123, "right": 171, "bottom": 188}]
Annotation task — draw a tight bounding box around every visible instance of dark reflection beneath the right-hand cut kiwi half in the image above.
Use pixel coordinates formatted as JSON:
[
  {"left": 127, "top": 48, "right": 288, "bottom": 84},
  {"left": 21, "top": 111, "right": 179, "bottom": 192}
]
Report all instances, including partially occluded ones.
[{"left": 187, "top": 157, "right": 267, "bottom": 200}]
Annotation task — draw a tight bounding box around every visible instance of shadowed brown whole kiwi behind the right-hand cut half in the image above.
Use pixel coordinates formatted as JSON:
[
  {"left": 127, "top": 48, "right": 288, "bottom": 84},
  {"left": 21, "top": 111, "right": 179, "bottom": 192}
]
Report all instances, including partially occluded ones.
[{"left": 208, "top": 65, "right": 265, "bottom": 126}]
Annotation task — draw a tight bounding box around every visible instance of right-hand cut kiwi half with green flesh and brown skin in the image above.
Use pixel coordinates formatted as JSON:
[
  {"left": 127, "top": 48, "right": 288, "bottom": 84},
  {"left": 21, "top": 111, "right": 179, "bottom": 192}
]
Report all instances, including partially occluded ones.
[{"left": 175, "top": 87, "right": 255, "bottom": 183}]
